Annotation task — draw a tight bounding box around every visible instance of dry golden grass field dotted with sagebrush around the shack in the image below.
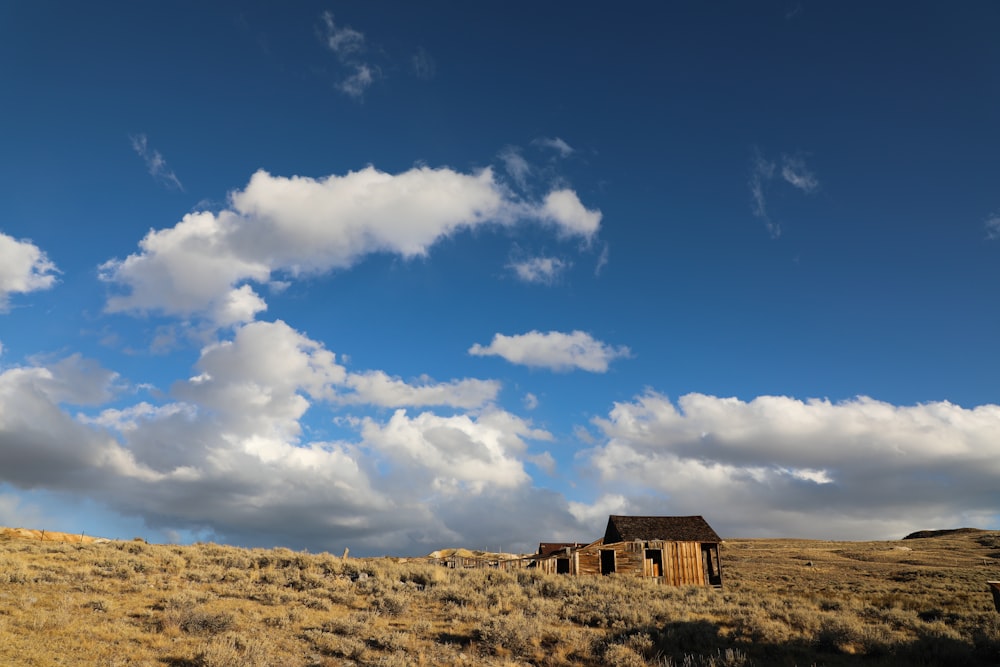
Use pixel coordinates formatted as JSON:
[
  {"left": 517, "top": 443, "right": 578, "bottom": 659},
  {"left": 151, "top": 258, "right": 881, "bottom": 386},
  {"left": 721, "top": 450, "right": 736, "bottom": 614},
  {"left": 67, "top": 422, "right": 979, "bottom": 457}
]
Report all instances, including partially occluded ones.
[{"left": 0, "top": 531, "right": 1000, "bottom": 667}]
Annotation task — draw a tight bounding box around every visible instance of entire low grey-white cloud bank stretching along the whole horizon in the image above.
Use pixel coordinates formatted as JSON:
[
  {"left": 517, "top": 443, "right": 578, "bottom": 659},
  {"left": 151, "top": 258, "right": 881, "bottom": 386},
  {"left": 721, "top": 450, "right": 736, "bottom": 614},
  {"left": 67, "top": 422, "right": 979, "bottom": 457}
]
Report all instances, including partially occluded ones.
[{"left": 0, "top": 334, "right": 1000, "bottom": 554}]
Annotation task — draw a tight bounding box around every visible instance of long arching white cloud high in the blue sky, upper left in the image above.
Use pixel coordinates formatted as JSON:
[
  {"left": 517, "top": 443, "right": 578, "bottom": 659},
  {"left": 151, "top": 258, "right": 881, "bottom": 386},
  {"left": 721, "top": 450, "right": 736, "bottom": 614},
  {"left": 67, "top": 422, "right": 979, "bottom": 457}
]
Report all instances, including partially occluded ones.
[{"left": 101, "top": 167, "right": 601, "bottom": 325}]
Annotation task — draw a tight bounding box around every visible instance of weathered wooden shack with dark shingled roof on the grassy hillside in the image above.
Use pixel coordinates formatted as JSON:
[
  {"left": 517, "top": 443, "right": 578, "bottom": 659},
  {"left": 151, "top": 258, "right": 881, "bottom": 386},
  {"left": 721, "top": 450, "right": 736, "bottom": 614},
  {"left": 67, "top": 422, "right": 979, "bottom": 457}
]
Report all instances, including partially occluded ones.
[{"left": 570, "top": 515, "right": 722, "bottom": 586}]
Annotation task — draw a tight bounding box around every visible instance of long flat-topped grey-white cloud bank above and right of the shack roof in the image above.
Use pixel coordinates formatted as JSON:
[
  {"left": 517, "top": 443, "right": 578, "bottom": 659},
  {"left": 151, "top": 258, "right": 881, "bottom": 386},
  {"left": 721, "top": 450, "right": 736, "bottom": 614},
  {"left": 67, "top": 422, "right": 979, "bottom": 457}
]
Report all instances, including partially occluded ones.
[{"left": 584, "top": 393, "right": 1000, "bottom": 539}]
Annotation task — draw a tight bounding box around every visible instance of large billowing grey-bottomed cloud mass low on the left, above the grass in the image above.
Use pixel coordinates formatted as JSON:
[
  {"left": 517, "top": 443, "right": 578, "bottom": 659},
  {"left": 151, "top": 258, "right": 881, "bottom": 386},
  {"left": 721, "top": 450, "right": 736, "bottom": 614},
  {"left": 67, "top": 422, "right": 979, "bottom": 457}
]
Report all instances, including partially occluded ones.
[{"left": 0, "top": 321, "right": 584, "bottom": 555}]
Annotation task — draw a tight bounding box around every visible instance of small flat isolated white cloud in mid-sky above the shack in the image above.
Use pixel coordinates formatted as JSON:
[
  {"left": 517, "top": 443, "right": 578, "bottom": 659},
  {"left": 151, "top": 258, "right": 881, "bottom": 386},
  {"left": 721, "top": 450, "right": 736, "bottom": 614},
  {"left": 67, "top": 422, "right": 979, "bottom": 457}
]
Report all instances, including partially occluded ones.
[{"left": 469, "top": 331, "right": 632, "bottom": 373}]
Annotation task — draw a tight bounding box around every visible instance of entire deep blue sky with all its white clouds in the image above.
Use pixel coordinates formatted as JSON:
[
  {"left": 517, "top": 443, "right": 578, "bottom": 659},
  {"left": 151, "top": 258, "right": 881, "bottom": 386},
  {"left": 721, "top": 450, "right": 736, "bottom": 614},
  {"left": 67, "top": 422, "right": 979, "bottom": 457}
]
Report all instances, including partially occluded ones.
[{"left": 0, "top": 2, "right": 1000, "bottom": 554}]
